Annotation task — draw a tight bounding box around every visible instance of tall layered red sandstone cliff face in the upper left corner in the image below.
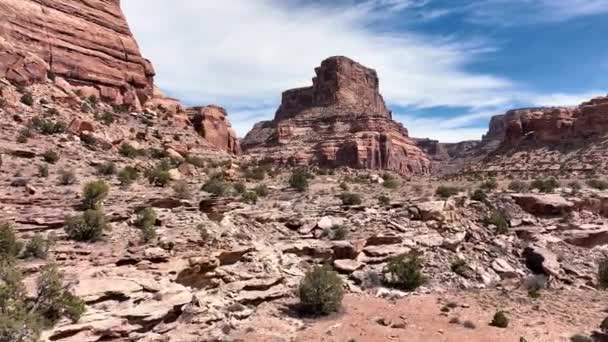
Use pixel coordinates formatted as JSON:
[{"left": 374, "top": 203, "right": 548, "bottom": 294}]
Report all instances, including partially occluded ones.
[{"left": 0, "top": 0, "right": 154, "bottom": 107}]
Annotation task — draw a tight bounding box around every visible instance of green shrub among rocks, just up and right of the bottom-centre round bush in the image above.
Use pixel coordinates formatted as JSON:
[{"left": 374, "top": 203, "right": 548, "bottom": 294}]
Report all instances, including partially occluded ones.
[{"left": 382, "top": 254, "right": 425, "bottom": 291}]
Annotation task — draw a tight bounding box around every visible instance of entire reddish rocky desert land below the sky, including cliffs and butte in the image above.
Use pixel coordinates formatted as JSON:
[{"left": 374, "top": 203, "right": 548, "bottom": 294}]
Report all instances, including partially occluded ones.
[{"left": 0, "top": 0, "right": 608, "bottom": 342}]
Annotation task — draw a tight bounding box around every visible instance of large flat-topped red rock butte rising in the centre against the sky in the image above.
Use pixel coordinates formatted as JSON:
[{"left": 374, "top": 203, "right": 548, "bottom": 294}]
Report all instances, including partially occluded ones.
[{"left": 242, "top": 57, "right": 430, "bottom": 174}]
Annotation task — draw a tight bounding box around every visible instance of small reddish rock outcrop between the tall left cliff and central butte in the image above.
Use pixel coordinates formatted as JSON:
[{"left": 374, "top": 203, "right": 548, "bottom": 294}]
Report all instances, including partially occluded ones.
[{"left": 187, "top": 105, "right": 241, "bottom": 154}]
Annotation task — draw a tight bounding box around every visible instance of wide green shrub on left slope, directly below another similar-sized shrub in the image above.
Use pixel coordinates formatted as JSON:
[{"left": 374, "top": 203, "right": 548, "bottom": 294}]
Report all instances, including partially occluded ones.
[{"left": 65, "top": 210, "right": 108, "bottom": 242}]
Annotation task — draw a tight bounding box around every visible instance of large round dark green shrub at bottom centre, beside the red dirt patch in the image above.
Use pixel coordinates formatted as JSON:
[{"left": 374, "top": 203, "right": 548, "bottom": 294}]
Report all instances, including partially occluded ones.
[{"left": 298, "top": 265, "right": 344, "bottom": 315}]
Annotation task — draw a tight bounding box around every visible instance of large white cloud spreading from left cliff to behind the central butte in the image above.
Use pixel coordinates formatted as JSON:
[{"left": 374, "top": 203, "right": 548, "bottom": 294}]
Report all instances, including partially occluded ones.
[{"left": 122, "top": 0, "right": 513, "bottom": 135}]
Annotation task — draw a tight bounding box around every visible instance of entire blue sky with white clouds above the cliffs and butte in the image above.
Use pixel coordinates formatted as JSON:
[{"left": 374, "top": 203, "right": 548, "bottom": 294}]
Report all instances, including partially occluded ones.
[{"left": 122, "top": 0, "right": 608, "bottom": 142}]
